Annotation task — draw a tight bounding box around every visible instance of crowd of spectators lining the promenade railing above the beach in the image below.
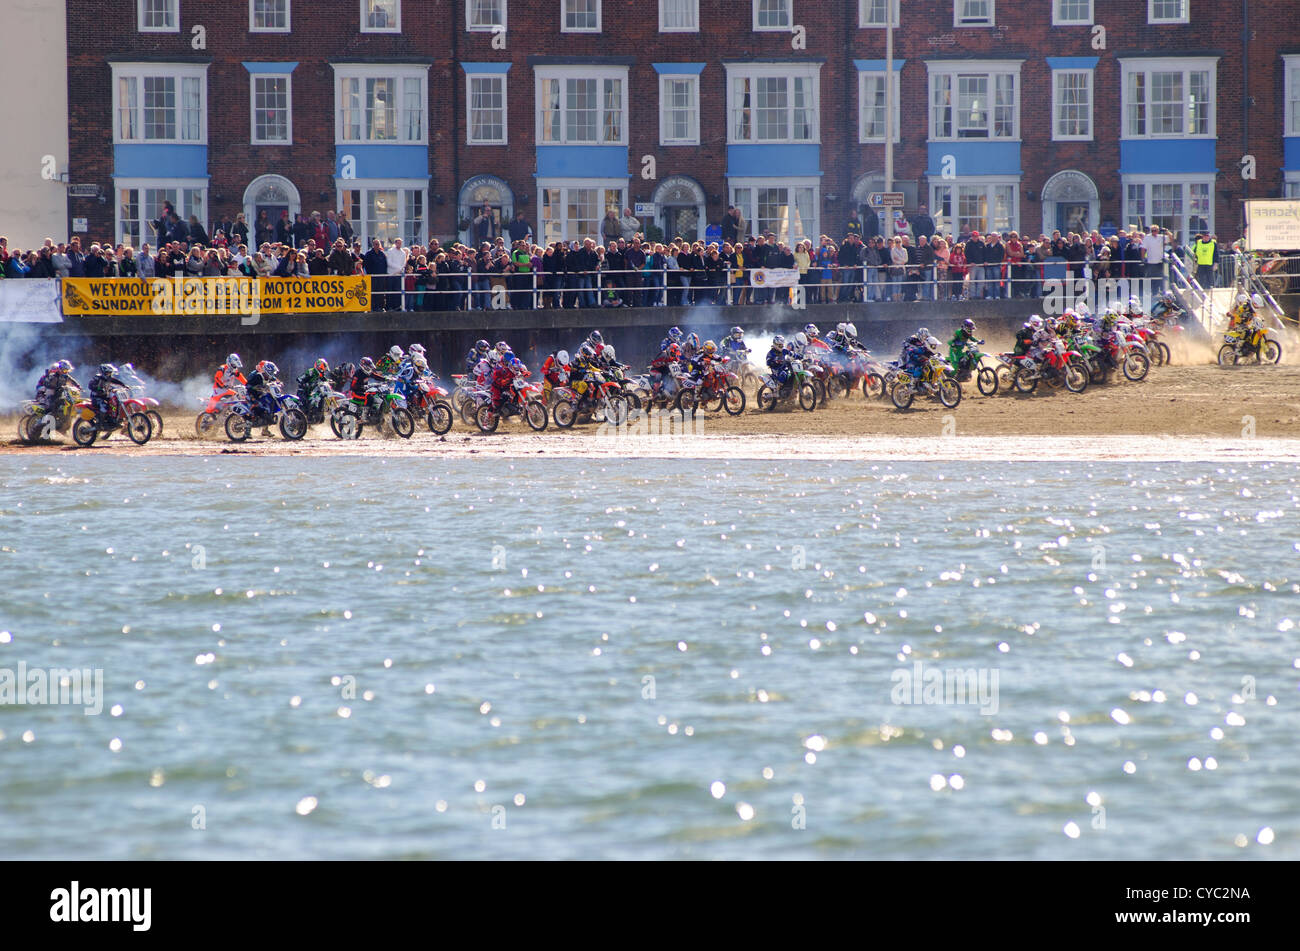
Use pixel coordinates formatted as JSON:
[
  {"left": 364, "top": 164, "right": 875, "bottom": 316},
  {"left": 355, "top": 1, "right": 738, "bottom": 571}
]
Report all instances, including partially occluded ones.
[{"left": 0, "top": 205, "right": 1235, "bottom": 311}]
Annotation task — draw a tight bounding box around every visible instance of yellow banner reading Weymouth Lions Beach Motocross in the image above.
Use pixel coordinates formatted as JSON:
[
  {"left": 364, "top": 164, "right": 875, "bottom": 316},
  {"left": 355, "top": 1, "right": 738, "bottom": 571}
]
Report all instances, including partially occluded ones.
[{"left": 61, "top": 274, "right": 371, "bottom": 317}]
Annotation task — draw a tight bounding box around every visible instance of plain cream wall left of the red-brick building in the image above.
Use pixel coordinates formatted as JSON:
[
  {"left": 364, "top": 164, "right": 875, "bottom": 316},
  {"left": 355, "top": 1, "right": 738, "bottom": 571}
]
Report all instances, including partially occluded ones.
[{"left": 0, "top": 0, "right": 67, "bottom": 249}]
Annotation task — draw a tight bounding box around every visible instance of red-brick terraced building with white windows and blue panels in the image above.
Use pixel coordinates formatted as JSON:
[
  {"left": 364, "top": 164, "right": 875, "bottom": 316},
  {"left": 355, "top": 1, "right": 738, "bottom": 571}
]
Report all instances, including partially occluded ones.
[{"left": 68, "top": 0, "right": 1300, "bottom": 250}]
